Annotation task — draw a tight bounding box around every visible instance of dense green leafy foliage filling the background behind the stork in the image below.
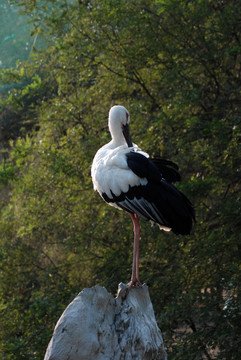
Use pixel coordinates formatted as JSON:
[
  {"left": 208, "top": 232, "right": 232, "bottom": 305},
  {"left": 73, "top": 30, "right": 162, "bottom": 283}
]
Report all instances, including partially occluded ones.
[{"left": 0, "top": 0, "right": 241, "bottom": 360}]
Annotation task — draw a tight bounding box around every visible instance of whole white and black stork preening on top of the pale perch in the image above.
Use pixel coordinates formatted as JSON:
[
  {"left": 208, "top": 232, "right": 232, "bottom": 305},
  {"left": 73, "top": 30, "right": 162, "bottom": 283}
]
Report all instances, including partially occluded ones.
[{"left": 91, "top": 105, "right": 195, "bottom": 288}]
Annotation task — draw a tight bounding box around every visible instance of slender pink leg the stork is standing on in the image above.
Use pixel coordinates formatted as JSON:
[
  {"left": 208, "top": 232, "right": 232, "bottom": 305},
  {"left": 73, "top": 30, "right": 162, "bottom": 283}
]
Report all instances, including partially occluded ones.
[{"left": 128, "top": 214, "right": 141, "bottom": 287}]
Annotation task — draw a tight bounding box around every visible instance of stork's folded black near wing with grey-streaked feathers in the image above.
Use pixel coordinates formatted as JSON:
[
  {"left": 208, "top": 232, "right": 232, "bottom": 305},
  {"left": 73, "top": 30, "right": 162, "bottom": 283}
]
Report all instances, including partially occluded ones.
[{"left": 102, "top": 152, "right": 195, "bottom": 235}]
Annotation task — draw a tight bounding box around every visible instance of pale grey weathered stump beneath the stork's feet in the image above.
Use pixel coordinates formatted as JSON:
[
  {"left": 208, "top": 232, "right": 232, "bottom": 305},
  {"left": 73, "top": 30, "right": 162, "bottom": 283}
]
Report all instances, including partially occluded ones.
[{"left": 44, "top": 284, "right": 166, "bottom": 360}]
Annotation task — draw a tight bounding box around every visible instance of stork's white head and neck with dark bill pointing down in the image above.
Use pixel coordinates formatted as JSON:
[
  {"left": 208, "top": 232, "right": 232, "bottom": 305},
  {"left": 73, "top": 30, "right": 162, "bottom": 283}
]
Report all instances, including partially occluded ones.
[{"left": 108, "top": 105, "right": 133, "bottom": 147}]
